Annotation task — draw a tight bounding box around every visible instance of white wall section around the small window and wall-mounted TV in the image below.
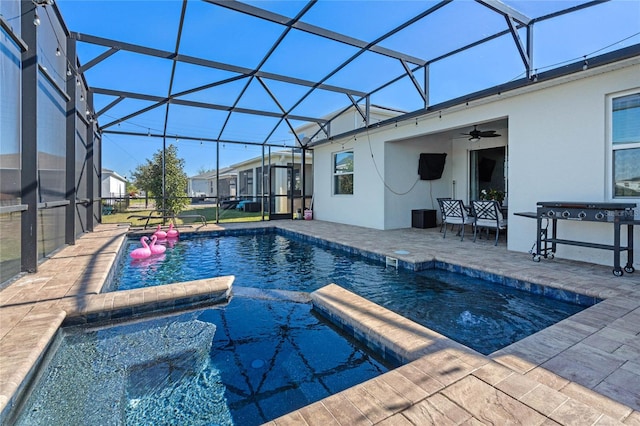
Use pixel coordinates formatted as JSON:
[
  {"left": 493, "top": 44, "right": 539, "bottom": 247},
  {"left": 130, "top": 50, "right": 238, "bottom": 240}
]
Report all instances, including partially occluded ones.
[{"left": 313, "top": 110, "right": 506, "bottom": 229}]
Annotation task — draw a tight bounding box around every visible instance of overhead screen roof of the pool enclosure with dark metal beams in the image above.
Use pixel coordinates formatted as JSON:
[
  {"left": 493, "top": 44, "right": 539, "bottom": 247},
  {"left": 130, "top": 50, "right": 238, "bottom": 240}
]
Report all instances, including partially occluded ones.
[{"left": 53, "top": 0, "right": 640, "bottom": 147}]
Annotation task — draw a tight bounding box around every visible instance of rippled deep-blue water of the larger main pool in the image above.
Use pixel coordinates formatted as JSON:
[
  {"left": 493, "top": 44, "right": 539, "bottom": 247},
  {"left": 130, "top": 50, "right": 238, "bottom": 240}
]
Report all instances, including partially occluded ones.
[{"left": 113, "top": 233, "right": 584, "bottom": 355}]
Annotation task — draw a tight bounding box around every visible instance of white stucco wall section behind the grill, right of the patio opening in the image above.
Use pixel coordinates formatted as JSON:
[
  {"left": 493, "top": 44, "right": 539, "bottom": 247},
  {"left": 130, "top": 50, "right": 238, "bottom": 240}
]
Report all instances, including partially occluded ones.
[{"left": 508, "top": 64, "right": 640, "bottom": 265}]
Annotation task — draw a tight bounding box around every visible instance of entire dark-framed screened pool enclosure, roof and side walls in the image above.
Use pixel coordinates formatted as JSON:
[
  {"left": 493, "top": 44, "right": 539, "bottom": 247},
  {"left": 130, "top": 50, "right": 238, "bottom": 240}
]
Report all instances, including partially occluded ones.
[{"left": 0, "top": 0, "right": 640, "bottom": 283}]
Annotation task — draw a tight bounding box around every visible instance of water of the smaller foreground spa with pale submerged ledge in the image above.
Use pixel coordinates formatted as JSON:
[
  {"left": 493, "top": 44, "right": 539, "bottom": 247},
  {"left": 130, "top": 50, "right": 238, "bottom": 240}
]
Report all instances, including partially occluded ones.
[{"left": 16, "top": 288, "right": 388, "bottom": 426}]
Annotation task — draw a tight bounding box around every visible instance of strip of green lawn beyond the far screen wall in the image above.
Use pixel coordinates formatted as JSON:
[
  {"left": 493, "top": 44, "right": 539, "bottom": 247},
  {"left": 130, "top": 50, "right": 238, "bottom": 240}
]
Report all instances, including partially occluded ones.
[{"left": 102, "top": 205, "right": 268, "bottom": 226}]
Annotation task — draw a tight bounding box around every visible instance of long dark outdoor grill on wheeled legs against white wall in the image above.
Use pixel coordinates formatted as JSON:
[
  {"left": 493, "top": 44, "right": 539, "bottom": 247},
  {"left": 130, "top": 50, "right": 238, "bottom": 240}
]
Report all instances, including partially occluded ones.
[{"left": 515, "top": 201, "right": 640, "bottom": 277}]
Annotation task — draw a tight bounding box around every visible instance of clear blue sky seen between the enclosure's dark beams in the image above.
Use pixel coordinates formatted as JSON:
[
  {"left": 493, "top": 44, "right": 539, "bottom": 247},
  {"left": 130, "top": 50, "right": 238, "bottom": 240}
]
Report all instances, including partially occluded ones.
[{"left": 57, "top": 0, "right": 640, "bottom": 177}]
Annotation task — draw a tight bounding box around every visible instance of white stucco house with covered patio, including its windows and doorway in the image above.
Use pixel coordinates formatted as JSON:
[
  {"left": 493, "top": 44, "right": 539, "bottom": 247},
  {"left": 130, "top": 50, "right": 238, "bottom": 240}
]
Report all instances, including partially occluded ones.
[{"left": 306, "top": 55, "right": 640, "bottom": 265}]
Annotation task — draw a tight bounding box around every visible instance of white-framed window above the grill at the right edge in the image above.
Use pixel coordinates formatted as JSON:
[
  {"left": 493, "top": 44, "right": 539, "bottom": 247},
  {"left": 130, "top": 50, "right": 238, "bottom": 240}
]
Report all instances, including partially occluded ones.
[{"left": 611, "top": 93, "right": 640, "bottom": 198}]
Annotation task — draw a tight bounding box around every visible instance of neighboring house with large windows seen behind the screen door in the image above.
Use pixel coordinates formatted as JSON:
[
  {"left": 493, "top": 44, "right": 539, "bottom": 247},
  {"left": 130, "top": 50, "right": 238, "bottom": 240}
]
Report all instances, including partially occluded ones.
[{"left": 231, "top": 150, "right": 313, "bottom": 214}]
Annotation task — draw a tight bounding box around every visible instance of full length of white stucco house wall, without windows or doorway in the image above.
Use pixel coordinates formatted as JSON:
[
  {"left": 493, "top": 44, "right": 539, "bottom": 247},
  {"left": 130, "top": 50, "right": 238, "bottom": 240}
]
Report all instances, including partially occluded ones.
[{"left": 314, "top": 58, "right": 640, "bottom": 265}]
